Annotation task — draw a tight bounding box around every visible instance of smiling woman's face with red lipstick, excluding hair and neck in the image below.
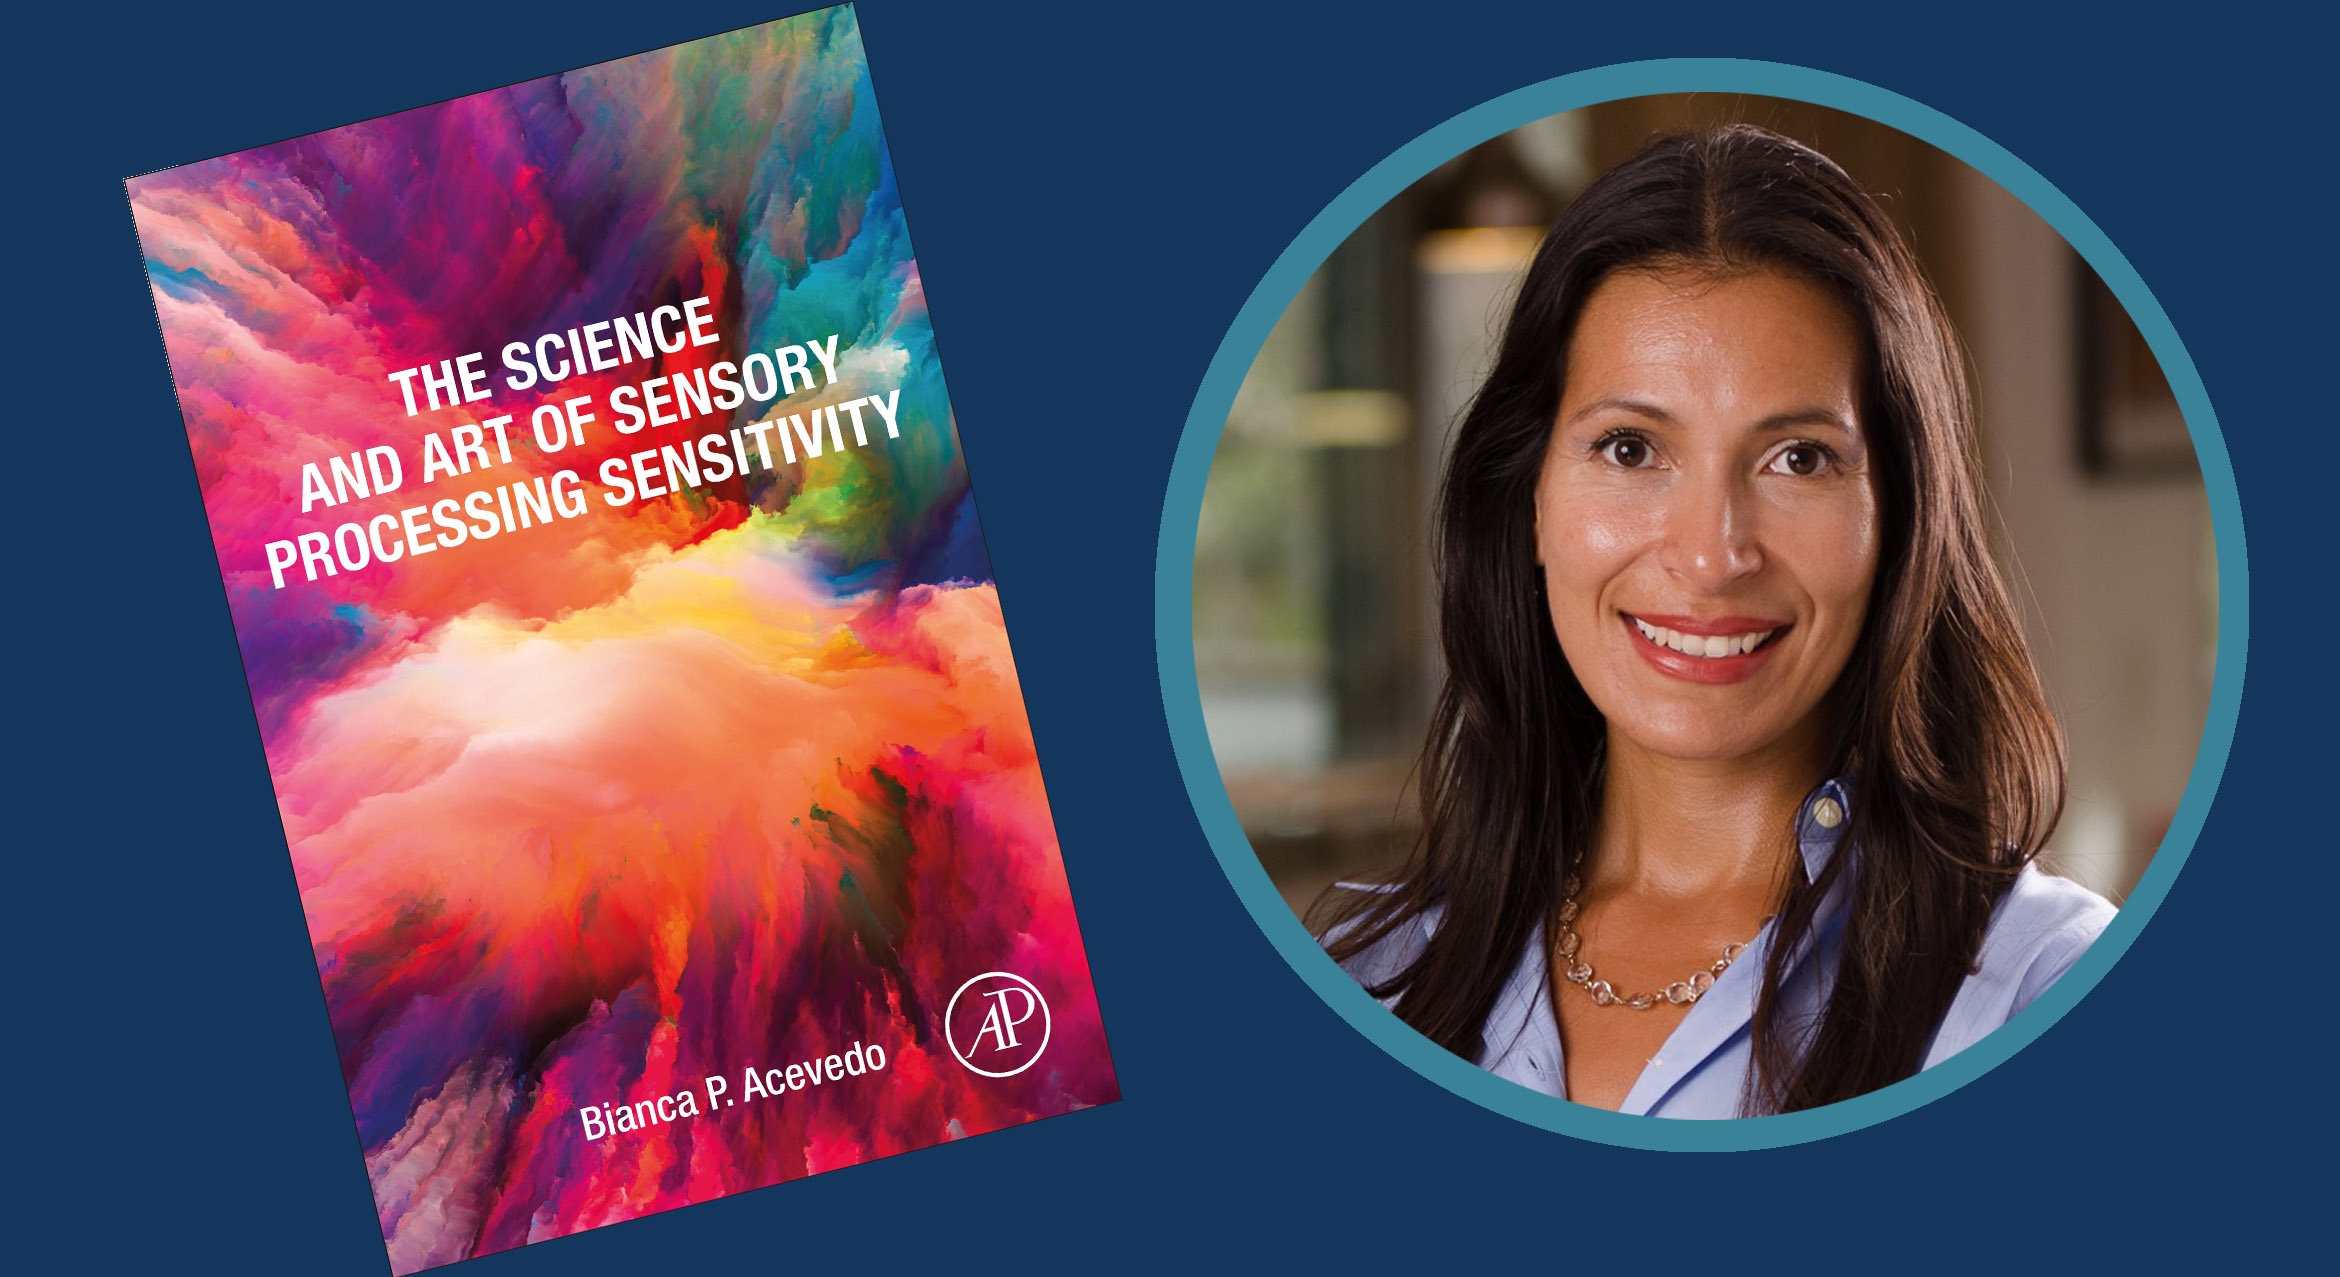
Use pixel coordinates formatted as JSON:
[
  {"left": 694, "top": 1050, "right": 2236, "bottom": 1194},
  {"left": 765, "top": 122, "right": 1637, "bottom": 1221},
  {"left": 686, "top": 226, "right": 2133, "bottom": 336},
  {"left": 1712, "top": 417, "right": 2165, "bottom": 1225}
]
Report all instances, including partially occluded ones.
[{"left": 1535, "top": 269, "right": 1877, "bottom": 760}]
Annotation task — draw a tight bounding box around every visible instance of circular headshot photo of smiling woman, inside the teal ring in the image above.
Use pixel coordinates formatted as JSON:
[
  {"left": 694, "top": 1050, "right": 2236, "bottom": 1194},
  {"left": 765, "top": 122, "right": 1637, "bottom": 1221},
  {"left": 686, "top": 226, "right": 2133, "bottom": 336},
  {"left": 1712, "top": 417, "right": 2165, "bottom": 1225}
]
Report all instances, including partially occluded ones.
[{"left": 1193, "top": 96, "right": 2216, "bottom": 1118}]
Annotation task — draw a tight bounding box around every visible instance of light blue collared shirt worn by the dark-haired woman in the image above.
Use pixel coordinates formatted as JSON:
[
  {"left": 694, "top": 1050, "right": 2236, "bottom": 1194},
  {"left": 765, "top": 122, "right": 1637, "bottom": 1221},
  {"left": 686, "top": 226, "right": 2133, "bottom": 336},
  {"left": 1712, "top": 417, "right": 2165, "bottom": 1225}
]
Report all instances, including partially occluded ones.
[{"left": 1346, "top": 781, "right": 2115, "bottom": 1118}]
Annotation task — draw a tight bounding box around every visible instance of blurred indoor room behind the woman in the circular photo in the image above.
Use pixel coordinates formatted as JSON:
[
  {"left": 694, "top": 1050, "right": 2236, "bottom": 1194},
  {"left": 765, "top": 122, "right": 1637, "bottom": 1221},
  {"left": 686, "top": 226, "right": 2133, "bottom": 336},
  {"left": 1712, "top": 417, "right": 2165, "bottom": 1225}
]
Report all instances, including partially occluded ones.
[{"left": 1193, "top": 94, "right": 2218, "bottom": 910}]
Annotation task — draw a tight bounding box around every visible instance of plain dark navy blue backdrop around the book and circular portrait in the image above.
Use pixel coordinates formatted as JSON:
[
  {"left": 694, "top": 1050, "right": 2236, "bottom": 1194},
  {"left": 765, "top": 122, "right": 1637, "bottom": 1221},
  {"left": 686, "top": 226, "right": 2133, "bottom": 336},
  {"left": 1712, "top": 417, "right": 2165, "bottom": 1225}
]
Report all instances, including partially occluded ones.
[{"left": 18, "top": 0, "right": 2335, "bottom": 1275}]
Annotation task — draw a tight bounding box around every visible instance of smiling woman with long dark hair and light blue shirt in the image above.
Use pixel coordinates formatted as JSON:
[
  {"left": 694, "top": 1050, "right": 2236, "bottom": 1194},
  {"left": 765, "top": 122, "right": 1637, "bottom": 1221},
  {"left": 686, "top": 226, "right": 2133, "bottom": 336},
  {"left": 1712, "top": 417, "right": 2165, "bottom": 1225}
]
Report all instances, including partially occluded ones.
[{"left": 1320, "top": 126, "right": 2113, "bottom": 1118}]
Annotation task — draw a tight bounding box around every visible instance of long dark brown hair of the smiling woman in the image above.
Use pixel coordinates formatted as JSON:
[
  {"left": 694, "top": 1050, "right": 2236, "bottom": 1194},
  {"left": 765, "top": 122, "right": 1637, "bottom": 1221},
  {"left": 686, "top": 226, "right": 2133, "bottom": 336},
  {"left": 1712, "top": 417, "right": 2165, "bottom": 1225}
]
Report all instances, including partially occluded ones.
[{"left": 1310, "top": 124, "right": 2064, "bottom": 1113}]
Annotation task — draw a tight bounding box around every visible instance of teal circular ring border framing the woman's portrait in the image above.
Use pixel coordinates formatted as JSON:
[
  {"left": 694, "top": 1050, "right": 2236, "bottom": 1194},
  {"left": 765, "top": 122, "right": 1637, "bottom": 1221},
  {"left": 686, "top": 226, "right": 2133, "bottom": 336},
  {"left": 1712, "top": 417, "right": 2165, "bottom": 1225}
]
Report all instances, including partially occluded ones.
[{"left": 1154, "top": 58, "right": 2251, "bottom": 1151}]
